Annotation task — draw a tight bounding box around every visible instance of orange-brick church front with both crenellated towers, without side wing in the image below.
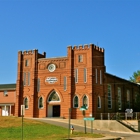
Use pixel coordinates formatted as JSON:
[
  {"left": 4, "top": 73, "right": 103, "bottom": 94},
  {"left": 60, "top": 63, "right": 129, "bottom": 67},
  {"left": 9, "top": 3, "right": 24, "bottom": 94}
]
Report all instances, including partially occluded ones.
[{"left": 15, "top": 44, "right": 105, "bottom": 118}]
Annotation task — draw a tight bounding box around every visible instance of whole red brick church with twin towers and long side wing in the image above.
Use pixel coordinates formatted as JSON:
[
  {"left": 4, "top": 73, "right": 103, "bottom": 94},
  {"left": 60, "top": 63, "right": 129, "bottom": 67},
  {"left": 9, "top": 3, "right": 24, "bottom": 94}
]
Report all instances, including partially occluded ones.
[{"left": 0, "top": 44, "right": 140, "bottom": 118}]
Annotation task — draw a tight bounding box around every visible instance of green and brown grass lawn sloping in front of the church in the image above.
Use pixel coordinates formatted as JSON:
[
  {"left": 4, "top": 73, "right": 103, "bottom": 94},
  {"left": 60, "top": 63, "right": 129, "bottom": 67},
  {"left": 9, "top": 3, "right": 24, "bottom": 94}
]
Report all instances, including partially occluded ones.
[{"left": 0, "top": 117, "right": 103, "bottom": 140}]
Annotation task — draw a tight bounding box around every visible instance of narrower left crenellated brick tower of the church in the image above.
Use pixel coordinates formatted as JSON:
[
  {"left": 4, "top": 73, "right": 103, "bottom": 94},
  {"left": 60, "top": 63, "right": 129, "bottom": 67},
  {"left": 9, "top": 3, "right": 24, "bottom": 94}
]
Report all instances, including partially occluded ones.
[{"left": 15, "top": 49, "right": 46, "bottom": 117}]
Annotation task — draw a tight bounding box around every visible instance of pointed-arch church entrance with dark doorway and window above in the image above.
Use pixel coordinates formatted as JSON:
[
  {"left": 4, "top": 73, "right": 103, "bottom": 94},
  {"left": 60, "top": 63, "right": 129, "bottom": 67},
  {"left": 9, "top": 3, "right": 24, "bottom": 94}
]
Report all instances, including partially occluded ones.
[{"left": 47, "top": 90, "right": 61, "bottom": 117}]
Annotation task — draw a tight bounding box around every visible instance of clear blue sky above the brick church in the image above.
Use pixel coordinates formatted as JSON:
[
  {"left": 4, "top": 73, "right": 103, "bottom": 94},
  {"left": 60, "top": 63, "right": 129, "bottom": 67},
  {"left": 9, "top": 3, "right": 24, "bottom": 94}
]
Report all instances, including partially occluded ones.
[{"left": 0, "top": 0, "right": 140, "bottom": 84}]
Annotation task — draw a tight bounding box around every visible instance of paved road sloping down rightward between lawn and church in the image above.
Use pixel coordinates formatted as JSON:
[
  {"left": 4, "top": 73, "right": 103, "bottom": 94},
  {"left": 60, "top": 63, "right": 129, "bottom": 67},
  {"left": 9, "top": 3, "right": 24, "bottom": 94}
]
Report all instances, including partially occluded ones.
[{"left": 29, "top": 118, "right": 140, "bottom": 140}]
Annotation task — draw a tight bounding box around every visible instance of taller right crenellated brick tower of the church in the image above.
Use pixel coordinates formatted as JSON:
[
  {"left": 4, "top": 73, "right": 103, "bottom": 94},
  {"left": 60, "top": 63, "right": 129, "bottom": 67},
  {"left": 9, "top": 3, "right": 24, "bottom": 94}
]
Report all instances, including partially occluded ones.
[{"left": 68, "top": 44, "right": 105, "bottom": 118}]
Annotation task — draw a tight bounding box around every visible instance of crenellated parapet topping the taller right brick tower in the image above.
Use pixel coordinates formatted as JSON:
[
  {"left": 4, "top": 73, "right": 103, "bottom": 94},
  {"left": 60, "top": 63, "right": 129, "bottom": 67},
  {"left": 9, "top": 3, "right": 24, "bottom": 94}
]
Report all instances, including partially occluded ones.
[{"left": 68, "top": 44, "right": 104, "bottom": 52}]
